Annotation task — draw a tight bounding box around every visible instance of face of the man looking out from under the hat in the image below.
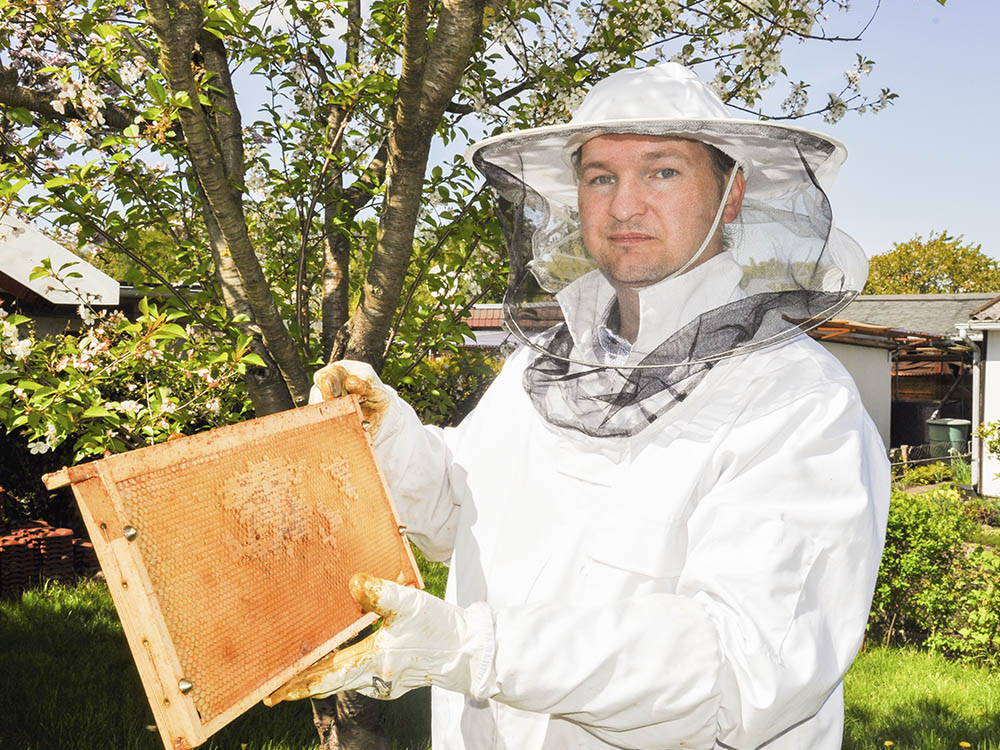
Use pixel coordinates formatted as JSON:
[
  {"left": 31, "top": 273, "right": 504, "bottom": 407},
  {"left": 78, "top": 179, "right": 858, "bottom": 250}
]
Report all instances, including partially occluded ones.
[{"left": 578, "top": 133, "right": 744, "bottom": 287}]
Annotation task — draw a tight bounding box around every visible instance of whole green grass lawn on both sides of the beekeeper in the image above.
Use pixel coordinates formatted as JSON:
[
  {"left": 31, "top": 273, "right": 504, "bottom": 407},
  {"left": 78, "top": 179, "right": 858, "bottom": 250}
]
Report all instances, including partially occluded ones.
[{"left": 0, "top": 571, "right": 1000, "bottom": 750}]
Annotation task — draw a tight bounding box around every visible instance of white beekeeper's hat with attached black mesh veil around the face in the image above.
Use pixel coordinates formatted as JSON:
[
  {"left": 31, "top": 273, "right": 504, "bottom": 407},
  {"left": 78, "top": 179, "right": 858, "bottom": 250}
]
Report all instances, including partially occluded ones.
[{"left": 467, "top": 63, "right": 867, "bottom": 436}]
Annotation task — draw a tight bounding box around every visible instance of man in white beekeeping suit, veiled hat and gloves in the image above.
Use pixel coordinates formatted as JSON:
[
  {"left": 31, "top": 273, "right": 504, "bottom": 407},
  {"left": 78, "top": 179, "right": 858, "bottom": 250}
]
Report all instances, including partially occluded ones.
[{"left": 273, "top": 63, "right": 889, "bottom": 750}]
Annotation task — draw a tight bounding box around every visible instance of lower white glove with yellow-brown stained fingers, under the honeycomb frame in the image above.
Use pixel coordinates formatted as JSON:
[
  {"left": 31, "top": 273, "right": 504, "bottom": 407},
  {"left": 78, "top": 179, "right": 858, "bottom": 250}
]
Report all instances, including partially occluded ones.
[{"left": 264, "top": 573, "right": 496, "bottom": 706}]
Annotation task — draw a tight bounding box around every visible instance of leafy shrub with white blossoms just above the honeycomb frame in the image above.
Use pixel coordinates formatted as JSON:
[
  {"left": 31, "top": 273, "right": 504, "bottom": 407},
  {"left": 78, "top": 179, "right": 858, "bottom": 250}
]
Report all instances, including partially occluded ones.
[{"left": 0, "top": 301, "right": 262, "bottom": 461}]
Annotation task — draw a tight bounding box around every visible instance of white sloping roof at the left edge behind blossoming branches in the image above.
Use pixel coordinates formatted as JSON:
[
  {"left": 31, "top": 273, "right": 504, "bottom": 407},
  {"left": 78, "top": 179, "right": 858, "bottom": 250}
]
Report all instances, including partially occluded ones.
[{"left": 0, "top": 213, "right": 119, "bottom": 307}]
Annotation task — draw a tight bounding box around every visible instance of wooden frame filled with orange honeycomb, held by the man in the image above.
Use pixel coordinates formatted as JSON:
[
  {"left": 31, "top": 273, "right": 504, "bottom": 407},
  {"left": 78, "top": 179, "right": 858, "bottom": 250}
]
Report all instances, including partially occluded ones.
[{"left": 44, "top": 397, "right": 423, "bottom": 750}]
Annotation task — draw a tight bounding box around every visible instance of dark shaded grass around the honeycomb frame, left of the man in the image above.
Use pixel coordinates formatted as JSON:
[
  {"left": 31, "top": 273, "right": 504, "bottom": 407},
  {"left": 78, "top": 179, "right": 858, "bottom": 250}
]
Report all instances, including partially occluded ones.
[{"left": 0, "top": 580, "right": 430, "bottom": 750}]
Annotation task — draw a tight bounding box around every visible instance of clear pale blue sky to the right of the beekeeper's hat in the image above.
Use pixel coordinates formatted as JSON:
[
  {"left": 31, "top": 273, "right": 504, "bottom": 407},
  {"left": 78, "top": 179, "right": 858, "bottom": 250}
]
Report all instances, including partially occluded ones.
[{"left": 783, "top": 0, "right": 1000, "bottom": 258}]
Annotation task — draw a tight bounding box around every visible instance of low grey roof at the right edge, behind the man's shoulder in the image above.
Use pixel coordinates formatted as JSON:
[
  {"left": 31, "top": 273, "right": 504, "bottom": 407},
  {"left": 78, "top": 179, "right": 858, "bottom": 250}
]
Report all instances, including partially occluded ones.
[{"left": 840, "top": 292, "right": 1000, "bottom": 336}]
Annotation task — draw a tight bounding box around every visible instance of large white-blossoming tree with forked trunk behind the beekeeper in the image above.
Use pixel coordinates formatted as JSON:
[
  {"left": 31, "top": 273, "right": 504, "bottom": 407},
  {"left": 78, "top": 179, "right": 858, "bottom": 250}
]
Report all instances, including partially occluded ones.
[{"left": 0, "top": 0, "right": 892, "bottom": 413}]
